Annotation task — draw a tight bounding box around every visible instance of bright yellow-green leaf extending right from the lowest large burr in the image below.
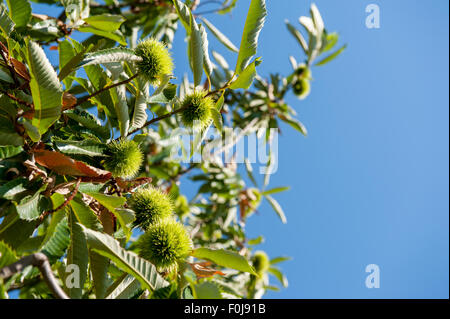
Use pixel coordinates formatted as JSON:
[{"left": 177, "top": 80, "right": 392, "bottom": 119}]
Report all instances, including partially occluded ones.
[{"left": 192, "top": 248, "right": 257, "bottom": 276}]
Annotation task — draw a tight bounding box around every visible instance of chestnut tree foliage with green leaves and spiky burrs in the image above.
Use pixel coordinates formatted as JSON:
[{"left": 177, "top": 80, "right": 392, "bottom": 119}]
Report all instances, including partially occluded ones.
[{"left": 0, "top": 0, "right": 345, "bottom": 299}]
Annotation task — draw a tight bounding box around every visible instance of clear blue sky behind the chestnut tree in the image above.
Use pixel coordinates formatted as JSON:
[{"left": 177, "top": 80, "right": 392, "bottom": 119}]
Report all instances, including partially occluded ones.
[{"left": 33, "top": 0, "right": 449, "bottom": 298}]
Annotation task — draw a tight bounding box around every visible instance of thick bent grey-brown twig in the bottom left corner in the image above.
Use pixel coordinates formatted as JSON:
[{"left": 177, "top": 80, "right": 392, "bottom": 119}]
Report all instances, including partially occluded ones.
[{"left": 0, "top": 253, "right": 69, "bottom": 299}]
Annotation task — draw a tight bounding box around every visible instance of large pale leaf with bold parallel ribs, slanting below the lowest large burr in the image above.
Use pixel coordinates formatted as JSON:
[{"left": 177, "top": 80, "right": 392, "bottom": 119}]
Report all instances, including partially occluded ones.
[{"left": 82, "top": 226, "right": 169, "bottom": 290}]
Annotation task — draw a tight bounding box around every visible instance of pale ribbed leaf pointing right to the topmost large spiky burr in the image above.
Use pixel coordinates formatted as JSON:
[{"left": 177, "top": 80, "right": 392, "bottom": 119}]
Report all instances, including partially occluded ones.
[{"left": 78, "top": 44, "right": 142, "bottom": 67}]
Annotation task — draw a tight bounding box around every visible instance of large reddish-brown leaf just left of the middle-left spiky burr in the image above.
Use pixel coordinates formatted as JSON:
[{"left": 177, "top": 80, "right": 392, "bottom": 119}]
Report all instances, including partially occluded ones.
[{"left": 34, "top": 150, "right": 111, "bottom": 180}]
